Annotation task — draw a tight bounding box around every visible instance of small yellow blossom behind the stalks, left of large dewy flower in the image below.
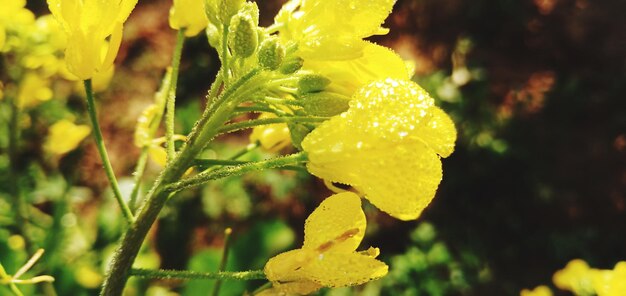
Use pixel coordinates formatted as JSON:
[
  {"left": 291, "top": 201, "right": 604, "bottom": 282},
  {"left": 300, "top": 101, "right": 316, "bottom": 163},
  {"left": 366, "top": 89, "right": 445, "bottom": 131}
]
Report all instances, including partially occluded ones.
[{"left": 250, "top": 113, "right": 291, "bottom": 151}]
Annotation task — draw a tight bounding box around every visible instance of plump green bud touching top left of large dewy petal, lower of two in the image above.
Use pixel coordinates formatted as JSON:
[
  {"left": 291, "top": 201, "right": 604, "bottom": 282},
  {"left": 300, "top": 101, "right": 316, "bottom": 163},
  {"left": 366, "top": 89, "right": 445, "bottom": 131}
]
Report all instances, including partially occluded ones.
[{"left": 300, "top": 92, "right": 350, "bottom": 116}]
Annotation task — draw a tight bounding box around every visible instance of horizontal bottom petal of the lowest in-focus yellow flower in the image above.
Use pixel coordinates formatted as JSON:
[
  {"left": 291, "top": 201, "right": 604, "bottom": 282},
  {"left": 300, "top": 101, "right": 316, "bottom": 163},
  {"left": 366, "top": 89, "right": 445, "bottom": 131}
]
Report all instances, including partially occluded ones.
[{"left": 304, "top": 253, "right": 388, "bottom": 288}]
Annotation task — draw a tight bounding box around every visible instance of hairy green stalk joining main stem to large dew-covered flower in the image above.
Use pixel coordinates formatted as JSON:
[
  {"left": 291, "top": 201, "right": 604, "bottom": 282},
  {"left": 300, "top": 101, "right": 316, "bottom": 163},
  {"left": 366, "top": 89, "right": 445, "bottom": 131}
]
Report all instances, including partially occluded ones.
[{"left": 164, "top": 152, "right": 307, "bottom": 192}]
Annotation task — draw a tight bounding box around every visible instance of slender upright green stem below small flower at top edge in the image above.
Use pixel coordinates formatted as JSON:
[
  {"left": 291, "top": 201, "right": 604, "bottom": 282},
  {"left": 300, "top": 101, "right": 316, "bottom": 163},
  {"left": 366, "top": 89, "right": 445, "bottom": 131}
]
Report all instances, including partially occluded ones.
[{"left": 165, "top": 28, "right": 185, "bottom": 163}]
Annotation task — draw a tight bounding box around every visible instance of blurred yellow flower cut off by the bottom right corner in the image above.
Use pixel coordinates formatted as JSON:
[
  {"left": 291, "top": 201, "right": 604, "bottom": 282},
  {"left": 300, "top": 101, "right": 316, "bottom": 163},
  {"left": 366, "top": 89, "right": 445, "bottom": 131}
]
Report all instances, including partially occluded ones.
[{"left": 591, "top": 261, "right": 626, "bottom": 296}]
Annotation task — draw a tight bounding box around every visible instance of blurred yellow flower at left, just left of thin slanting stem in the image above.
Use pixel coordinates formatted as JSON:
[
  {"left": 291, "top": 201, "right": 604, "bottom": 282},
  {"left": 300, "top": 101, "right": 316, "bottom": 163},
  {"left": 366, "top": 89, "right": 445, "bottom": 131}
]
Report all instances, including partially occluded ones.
[{"left": 44, "top": 119, "right": 91, "bottom": 155}]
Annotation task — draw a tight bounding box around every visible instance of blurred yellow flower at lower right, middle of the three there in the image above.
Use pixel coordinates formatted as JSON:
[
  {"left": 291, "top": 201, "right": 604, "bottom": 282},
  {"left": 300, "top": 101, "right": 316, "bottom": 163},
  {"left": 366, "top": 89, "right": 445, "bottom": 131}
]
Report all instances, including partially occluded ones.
[{"left": 552, "top": 259, "right": 593, "bottom": 294}]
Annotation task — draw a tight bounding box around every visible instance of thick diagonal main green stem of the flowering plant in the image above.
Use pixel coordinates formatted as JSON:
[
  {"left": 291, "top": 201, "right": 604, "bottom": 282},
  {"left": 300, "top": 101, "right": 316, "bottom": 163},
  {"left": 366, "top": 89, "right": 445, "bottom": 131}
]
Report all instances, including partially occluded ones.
[{"left": 100, "top": 70, "right": 263, "bottom": 296}]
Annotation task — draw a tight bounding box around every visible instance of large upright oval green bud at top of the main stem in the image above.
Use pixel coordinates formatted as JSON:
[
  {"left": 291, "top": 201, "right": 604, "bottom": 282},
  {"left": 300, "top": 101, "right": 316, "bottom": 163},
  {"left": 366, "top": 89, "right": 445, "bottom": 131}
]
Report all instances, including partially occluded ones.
[{"left": 228, "top": 13, "right": 259, "bottom": 58}]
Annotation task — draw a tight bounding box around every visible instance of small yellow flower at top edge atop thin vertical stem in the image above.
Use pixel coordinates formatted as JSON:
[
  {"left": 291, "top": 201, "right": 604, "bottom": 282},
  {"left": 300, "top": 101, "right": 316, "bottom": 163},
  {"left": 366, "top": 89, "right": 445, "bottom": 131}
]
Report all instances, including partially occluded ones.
[{"left": 169, "top": 0, "right": 209, "bottom": 36}]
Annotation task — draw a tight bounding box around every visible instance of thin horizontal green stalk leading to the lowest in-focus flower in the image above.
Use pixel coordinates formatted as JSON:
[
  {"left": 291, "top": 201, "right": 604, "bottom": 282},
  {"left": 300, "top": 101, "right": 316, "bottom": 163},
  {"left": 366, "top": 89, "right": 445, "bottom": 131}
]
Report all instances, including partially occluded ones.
[{"left": 130, "top": 268, "right": 265, "bottom": 281}]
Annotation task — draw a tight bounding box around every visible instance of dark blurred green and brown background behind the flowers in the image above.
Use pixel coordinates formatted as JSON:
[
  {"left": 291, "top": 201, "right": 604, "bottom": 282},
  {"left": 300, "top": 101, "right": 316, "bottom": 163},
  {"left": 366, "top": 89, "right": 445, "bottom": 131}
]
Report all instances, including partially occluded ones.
[{"left": 0, "top": 0, "right": 626, "bottom": 295}]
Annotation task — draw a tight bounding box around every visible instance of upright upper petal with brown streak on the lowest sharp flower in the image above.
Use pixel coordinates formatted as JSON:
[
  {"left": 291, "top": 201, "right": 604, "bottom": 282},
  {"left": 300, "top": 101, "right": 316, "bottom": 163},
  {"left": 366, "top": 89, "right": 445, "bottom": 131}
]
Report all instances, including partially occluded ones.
[{"left": 302, "top": 192, "right": 366, "bottom": 253}]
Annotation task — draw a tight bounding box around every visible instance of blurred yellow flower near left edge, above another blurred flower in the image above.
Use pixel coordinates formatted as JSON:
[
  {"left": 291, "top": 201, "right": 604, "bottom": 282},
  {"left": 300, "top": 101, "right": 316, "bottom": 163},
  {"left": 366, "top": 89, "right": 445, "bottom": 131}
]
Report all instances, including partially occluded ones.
[{"left": 17, "top": 72, "right": 52, "bottom": 108}]
